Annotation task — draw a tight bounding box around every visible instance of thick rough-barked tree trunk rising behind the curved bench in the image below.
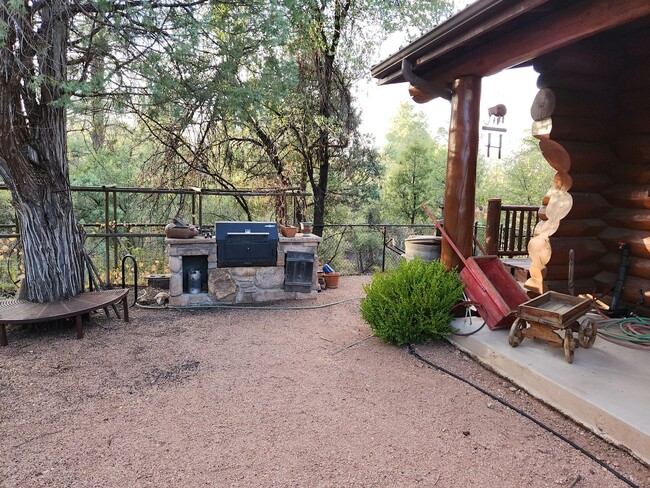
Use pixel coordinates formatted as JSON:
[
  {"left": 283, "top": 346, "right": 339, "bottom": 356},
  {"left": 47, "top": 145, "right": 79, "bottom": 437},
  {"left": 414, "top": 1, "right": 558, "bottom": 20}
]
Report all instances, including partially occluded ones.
[{"left": 0, "top": 0, "right": 83, "bottom": 302}]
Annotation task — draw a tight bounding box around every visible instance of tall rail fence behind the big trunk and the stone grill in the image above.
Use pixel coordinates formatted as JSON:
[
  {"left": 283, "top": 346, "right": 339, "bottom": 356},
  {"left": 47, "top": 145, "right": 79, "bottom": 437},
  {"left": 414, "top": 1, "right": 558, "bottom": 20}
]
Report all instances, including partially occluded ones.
[{"left": 0, "top": 185, "right": 308, "bottom": 292}]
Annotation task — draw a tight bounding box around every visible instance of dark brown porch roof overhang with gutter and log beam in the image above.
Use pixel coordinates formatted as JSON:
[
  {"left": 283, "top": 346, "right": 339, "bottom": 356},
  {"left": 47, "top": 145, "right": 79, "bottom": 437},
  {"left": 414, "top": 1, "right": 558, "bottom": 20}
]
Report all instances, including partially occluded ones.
[{"left": 371, "top": 0, "right": 650, "bottom": 101}]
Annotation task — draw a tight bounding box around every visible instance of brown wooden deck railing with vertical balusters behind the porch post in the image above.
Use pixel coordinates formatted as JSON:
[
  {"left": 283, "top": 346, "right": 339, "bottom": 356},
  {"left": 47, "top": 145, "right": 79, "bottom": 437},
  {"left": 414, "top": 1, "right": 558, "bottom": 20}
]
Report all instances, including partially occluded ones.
[{"left": 485, "top": 198, "right": 539, "bottom": 257}]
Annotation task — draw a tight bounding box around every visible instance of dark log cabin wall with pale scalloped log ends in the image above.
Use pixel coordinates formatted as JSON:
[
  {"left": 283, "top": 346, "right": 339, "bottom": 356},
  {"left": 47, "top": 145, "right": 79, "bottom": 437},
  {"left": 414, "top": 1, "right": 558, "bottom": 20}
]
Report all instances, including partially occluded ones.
[{"left": 526, "top": 28, "right": 650, "bottom": 303}]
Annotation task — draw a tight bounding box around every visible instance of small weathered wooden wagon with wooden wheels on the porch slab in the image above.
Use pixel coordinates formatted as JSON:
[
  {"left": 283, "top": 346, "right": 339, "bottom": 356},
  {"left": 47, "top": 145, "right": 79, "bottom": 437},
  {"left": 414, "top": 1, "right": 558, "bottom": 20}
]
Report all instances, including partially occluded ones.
[{"left": 508, "top": 291, "right": 598, "bottom": 363}]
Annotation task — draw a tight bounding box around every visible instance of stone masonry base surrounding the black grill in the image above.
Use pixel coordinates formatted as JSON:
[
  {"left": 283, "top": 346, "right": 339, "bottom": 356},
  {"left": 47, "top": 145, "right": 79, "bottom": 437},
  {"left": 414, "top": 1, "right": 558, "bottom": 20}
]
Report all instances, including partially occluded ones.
[{"left": 165, "top": 234, "right": 322, "bottom": 307}]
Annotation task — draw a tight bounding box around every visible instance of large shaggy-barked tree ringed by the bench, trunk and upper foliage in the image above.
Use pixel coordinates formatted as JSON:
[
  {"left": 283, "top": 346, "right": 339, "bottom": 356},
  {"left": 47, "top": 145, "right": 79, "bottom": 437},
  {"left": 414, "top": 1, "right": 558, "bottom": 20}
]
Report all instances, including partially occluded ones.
[{"left": 0, "top": 0, "right": 219, "bottom": 302}]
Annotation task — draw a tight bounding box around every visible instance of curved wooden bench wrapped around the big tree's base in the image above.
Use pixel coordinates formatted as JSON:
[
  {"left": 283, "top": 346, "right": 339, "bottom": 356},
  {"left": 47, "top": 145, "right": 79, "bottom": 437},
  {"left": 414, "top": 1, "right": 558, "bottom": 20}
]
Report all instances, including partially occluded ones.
[{"left": 0, "top": 289, "right": 129, "bottom": 346}]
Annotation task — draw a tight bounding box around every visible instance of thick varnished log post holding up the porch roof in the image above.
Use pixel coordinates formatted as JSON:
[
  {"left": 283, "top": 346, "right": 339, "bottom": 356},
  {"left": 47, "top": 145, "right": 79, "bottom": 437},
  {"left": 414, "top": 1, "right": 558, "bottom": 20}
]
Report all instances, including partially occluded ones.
[{"left": 440, "top": 76, "right": 481, "bottom": 269}]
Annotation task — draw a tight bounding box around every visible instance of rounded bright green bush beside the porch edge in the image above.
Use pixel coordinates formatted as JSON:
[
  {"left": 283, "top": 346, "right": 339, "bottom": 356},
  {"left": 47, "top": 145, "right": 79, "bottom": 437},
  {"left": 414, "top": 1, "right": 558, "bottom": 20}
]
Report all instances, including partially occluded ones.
[{"left": 361, "top": 259, "right": 464, "bottom": 346}]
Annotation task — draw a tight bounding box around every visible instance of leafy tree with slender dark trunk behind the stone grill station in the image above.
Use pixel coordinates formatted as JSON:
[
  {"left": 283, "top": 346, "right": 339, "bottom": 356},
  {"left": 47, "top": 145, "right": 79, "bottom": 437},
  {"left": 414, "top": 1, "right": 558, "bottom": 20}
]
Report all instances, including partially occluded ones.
[{"left": 115, "top": 0, "right": 451, "bottom": 233}]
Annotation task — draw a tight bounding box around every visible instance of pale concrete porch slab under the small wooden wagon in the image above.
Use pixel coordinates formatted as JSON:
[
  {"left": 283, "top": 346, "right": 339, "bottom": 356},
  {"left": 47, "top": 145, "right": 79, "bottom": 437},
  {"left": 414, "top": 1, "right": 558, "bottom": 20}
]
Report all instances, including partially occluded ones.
[{"left": 449, "top": 317, "right": 650, "bottom": 464}]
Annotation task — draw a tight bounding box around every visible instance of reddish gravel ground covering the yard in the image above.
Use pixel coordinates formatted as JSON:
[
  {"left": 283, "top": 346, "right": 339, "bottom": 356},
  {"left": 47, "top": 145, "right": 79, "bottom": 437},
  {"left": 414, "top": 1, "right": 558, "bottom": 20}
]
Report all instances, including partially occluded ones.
[{"left": 0, "top": 277, "right": 650, "bottom": 488}]
